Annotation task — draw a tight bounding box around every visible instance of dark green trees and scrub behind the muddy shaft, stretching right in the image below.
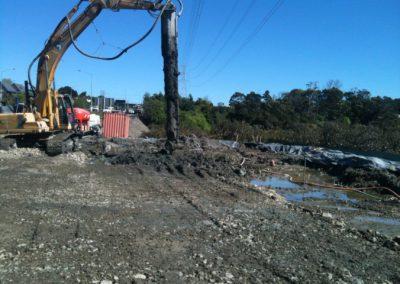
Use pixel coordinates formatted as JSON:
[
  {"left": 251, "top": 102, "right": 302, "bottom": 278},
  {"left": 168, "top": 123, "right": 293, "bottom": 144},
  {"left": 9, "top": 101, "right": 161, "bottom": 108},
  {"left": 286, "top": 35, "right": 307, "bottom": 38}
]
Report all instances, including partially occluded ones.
[{"left": 143, "top": 84, "right": 400, "bottom": 153}]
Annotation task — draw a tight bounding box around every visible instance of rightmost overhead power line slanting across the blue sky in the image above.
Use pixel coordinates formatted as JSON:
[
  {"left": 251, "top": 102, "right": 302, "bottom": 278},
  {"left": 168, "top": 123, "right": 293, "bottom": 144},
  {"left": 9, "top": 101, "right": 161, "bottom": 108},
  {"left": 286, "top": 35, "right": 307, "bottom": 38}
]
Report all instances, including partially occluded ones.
[{"left": 191, "top": 0, "right": 285, "bottom": 87}]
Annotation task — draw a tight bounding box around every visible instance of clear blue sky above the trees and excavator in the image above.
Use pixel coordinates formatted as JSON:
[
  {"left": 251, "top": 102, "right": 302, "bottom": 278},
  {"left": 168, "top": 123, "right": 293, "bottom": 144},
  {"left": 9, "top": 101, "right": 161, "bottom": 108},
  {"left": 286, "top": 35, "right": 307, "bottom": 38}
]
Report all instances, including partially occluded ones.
[{"left": 0, "top": 0, "right": 400, "bottom": 103}]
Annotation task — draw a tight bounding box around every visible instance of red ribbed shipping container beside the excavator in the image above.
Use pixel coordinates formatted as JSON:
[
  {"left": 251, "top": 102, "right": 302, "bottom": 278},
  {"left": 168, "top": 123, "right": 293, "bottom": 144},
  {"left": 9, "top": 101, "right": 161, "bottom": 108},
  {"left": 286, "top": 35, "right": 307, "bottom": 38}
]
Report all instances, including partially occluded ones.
[{"left": 103, "top": 113, "right": 130, "bottom": 138}]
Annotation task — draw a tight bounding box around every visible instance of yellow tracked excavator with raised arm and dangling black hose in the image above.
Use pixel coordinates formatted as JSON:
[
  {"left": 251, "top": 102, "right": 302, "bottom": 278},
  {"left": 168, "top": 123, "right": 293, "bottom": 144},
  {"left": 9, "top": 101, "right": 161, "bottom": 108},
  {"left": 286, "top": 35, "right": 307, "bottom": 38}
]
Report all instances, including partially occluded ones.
[{"left": 0, "top": 0, "right": 175, "bottom": 155}]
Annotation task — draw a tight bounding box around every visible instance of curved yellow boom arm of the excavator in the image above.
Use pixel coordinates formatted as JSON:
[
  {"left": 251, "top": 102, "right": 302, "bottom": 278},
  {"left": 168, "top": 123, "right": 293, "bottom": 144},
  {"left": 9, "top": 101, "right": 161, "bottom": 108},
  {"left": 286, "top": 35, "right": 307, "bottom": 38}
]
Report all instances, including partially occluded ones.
[{"left": 34, "top": 0, "right": 164, "bottom": 130}]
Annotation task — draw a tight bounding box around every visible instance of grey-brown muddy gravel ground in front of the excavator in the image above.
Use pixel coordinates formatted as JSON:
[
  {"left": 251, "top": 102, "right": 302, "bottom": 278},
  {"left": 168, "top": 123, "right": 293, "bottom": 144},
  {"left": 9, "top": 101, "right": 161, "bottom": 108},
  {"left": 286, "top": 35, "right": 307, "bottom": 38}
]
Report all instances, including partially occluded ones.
[{"left": 0, "top": 138, "right": 400, "bottom": 283}]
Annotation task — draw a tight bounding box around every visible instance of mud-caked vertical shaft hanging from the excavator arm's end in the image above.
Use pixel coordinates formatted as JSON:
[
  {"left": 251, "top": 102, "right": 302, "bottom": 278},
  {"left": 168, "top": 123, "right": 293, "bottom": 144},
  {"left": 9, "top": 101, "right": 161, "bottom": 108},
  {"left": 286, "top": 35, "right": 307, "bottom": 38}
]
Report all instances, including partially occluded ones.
[{"left": 161, "top": 5, "right": 179, "bottom": 144}]
